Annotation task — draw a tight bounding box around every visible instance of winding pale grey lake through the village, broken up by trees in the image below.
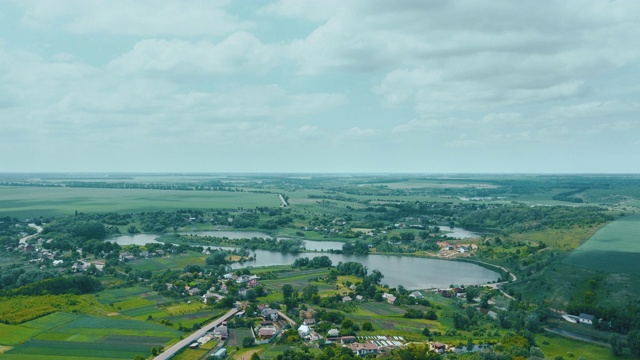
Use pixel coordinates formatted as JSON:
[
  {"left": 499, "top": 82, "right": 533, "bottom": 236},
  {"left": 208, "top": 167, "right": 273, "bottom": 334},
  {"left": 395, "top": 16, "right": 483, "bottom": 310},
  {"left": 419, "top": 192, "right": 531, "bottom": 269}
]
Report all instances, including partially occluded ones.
[{"left": 110, "top": 231, "right": 500, "bottom": 289}]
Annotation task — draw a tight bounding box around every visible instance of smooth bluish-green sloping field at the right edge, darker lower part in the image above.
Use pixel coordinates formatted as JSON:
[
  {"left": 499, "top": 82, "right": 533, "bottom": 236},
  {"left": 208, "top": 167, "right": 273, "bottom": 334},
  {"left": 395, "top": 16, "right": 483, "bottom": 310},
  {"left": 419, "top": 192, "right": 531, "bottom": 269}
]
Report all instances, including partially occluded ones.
[{"left": 564, "top": 215, "right": 640, "bottom": 274}]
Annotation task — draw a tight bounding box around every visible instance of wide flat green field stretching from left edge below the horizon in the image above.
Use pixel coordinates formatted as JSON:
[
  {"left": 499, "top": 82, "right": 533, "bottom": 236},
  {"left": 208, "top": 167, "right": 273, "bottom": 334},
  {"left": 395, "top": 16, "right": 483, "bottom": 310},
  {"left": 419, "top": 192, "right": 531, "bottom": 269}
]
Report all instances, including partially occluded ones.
[{"left": 0, "top": 186, "right": 280, "bottom": 218}]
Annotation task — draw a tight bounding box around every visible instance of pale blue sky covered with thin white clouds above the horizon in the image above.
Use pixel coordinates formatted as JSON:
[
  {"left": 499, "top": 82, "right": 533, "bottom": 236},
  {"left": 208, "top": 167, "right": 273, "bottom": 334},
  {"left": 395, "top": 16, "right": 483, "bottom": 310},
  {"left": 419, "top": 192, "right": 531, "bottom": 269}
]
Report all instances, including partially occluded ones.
[{"left": 0, "top": 0, "right": 640, "bottom": 173}]
